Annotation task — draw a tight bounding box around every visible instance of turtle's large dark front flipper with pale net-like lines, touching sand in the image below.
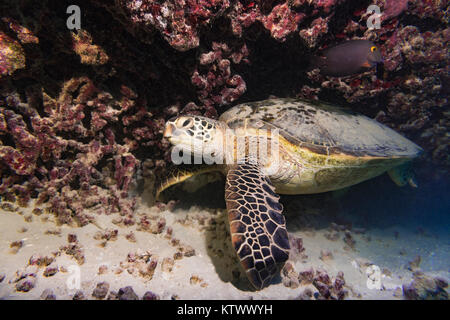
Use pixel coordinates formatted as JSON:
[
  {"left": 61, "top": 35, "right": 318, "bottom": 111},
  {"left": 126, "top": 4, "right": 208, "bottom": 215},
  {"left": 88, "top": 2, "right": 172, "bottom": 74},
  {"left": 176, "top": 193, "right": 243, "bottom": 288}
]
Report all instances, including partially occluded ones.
[{"left": 225, "top": 163, "right": 289, "bottom": 289}]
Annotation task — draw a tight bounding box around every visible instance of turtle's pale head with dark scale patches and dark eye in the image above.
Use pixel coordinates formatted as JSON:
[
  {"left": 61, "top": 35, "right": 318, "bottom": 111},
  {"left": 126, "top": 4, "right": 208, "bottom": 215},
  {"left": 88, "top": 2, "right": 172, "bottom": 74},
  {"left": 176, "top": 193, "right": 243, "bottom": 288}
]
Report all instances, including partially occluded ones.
[{"left": 164, "top": 116, "right": 226, "bottom": 159}]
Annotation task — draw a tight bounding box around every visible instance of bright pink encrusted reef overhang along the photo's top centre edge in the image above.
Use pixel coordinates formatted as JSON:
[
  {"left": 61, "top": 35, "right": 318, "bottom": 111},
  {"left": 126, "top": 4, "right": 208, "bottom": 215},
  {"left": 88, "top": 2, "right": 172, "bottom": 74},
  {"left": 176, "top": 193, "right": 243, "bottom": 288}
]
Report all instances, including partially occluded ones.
[{"left": 117, "top": 0, "right": 312, "bottom": 47}]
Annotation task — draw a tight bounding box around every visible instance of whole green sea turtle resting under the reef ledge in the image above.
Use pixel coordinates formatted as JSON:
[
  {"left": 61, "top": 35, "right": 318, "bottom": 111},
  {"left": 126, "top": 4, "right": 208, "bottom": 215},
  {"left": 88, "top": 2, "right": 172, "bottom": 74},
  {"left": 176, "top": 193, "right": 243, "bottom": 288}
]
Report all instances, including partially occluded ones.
[{"left": 157, "top": 99, "right": 422, "bottom": 289}]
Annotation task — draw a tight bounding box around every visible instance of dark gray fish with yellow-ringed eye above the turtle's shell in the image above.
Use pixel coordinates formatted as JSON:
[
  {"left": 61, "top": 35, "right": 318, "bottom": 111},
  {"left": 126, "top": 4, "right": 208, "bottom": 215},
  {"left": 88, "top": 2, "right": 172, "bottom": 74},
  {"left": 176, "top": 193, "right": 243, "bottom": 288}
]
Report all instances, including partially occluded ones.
[{"left": 311, "top": 40, "right": 383, "bottom": 77}]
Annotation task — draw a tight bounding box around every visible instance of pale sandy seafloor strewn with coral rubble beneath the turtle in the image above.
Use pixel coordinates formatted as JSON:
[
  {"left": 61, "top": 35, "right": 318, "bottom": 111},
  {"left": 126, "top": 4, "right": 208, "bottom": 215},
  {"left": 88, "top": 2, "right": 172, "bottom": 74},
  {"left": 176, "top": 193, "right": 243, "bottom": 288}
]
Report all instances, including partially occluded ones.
[{"left": 0, "top": 172, "right": 450, "bottom": 300}]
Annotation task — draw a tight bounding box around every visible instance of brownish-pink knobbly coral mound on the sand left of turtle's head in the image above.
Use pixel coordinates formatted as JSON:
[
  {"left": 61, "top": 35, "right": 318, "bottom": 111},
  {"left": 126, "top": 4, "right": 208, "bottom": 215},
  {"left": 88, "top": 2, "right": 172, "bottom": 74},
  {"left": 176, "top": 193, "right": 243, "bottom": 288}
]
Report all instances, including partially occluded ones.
[{"left": 0, "top": 77, "right": 163, "bottom": 225}]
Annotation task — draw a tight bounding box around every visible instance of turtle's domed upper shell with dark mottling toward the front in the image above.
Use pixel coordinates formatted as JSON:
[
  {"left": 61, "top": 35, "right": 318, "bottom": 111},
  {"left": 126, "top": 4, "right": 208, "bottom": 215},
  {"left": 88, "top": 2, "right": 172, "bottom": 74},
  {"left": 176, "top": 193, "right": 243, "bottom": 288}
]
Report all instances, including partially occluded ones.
[{"left": 220, "top": 99, "right": 422, "bottom": 158}]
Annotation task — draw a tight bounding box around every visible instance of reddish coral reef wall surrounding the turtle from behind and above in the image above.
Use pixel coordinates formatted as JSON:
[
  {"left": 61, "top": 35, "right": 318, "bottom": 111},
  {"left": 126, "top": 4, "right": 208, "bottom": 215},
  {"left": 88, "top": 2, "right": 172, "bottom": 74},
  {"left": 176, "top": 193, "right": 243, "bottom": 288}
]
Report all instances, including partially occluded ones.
[{"left": 0, "top": 0, "right": 450, "bottom": 228}]
